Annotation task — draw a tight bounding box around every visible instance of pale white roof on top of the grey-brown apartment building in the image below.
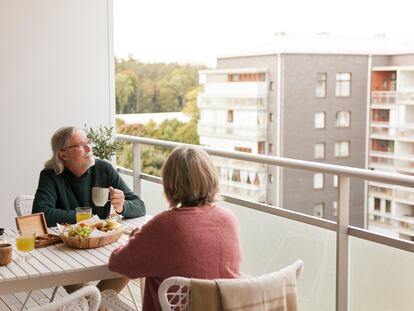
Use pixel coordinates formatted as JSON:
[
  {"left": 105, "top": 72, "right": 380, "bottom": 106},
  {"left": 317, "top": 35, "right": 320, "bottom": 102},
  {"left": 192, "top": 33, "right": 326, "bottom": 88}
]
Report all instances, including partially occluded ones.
[{"left": 218, "top": 33, "right": 414, "bottom": 59}]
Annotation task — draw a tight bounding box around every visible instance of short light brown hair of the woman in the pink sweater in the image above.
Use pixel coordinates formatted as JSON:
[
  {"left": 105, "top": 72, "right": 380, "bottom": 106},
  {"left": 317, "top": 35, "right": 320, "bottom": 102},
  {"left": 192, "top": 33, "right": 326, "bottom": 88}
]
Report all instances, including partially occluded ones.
[{"left": 161, "top": 146, "right": 219, "bottom": 207}]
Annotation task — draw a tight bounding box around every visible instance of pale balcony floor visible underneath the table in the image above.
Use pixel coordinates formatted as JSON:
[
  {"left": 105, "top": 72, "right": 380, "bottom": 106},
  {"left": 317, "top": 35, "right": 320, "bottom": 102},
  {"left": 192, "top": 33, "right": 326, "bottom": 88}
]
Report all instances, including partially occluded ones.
[{"left": 0, "top": 280, "right": 141, "bottom": 311}]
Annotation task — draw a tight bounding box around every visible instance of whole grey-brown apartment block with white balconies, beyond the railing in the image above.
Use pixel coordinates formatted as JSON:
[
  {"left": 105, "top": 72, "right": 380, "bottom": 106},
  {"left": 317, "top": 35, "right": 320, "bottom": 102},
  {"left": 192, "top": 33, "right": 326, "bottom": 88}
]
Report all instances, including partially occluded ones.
[{"left": 198, "top": 36, "right": 414, "bottom": 232}]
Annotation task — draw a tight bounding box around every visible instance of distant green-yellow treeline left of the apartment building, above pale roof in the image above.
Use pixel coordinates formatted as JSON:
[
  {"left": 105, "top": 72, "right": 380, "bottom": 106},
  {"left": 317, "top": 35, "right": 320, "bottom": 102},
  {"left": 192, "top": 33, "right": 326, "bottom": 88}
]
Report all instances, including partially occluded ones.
[{"left": 115, "top": 58, "right": 206, "bottom": 113}]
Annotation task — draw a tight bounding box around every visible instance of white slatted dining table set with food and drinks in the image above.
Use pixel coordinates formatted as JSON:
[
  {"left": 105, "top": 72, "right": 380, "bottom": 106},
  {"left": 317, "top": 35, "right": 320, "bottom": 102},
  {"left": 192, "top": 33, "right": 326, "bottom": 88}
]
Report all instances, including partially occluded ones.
[{"left": 0, "top": 215, "right": 151, "bottom": 295}]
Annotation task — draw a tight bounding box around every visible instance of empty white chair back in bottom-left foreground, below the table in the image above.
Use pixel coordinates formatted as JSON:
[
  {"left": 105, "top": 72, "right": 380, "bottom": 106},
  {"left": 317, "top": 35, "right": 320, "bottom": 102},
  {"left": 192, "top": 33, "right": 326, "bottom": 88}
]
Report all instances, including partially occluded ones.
[{"left": 30, "top": 285, "right": 101, "bottom": 311}]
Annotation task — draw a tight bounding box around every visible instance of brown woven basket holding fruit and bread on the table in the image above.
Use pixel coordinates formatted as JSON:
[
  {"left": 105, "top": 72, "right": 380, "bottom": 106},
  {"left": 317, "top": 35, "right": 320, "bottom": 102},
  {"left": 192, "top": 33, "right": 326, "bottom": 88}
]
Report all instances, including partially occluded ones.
[{"left": 61, "top": 227, "right": 124, "bottom": 248}]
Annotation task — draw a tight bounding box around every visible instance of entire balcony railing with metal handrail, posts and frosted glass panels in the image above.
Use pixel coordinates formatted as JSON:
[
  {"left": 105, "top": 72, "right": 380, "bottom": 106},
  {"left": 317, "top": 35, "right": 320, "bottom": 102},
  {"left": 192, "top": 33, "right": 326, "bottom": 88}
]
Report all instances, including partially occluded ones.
[{"left": 118, "top": 135, "right": 414, "bottom": 311}]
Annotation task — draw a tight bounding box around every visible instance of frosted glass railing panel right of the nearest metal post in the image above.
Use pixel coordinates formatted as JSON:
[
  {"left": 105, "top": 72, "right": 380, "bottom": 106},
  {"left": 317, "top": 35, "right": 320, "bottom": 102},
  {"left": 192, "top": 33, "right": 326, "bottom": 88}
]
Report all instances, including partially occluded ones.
[{"left": 349, "top": 237, "right": 414, "bottom": 311}]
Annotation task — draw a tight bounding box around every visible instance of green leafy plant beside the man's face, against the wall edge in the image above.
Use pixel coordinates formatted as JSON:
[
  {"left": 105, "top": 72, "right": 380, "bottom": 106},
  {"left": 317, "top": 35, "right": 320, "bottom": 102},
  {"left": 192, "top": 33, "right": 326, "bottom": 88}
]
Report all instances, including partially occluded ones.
[{"left": 85, "top": 125, "right": 122, "bottom": 160}]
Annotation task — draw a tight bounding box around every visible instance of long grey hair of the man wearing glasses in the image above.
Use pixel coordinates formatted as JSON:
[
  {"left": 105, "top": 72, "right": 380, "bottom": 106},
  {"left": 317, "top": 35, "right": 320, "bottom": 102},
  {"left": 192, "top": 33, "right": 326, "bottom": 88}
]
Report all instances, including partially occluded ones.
[{"left": 45, "top": 126, "right": 80, "bottom": 175}]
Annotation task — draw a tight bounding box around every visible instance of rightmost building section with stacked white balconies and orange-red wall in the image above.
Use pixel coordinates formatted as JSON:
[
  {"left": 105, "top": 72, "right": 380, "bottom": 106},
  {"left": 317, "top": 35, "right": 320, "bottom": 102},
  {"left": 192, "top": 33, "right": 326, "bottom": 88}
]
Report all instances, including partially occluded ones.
[{"left": 368, "top": 54, "right": 414, "bottom": 240}]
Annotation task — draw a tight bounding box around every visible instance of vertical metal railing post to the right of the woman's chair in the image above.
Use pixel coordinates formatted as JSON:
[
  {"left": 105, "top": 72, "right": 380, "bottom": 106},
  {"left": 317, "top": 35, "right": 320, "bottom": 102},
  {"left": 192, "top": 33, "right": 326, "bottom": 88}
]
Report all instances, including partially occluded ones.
[{"left": 336, "top": 175, "right": 350, "bottom": 311}]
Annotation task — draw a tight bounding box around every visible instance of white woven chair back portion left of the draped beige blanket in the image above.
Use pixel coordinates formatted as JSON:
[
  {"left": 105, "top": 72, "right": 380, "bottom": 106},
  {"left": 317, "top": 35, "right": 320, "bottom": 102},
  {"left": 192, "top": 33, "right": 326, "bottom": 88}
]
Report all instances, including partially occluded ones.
[{"left": 158, "top": 276, "right": 191, "bottom": 311}]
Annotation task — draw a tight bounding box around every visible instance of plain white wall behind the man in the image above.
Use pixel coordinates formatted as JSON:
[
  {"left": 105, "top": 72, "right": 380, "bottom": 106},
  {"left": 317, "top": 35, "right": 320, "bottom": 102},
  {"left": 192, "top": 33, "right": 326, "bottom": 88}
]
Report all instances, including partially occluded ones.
[{"left": 0, "top": 0, "right": 115, "bottom": 227}]
